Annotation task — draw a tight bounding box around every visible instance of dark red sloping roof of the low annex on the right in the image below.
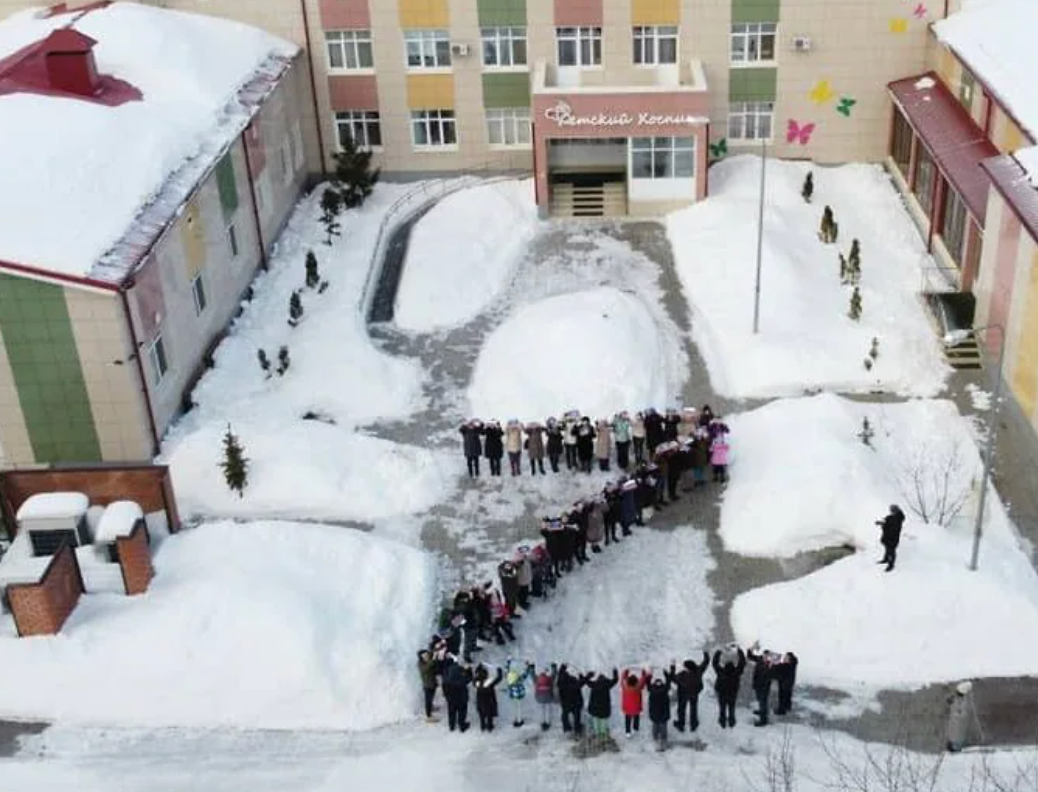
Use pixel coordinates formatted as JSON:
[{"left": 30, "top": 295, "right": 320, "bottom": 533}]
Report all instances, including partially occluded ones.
[{"left": 886, "top": 72, "right": 999, "bottom": 227}]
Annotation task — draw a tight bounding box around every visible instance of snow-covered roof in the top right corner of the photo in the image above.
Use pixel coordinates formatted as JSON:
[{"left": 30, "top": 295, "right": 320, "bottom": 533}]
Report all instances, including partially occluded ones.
[{"left": 933, "top": 0, "right": 1038, "bottom": 138}]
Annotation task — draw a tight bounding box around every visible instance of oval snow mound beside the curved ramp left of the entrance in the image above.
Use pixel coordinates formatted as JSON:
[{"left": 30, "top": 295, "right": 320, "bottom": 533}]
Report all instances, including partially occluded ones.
[{"left": 393, "top": 179, "right": 538, "bottom": 332}]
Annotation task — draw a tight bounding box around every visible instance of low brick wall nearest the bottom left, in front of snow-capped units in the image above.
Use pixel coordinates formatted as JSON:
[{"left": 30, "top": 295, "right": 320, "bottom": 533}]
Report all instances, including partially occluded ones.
[{"left": 7, "top": 545, "right": 83, "bottom": 637}]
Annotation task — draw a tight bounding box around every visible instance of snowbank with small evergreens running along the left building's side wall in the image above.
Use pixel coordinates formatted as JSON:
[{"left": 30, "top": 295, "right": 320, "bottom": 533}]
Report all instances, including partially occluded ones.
[{"left": 163, "top": 185, "right": 450, "bottom": 520}]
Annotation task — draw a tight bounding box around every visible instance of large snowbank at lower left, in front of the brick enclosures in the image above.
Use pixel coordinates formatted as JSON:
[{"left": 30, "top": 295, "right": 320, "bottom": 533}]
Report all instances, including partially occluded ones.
[{"left": 0, "top": 522, "right": 436, "bottom": 730}]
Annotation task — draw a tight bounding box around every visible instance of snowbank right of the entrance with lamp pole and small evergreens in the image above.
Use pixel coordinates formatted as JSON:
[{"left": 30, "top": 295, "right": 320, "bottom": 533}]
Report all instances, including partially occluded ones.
[{"left": 666, "top": 156, "right": 949, "bottom": 398}]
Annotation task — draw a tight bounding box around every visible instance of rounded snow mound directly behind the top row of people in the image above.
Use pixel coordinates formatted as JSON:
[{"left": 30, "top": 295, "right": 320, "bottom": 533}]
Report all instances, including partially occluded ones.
[{"left": 468, "top": 288, "right": 683, "bottom": 420}]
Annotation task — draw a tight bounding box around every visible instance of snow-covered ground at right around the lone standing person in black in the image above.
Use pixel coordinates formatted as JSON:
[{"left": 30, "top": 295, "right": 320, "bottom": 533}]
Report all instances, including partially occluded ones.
[{"left": 720, "top": 394, "right": 1038, "bottom": 690}]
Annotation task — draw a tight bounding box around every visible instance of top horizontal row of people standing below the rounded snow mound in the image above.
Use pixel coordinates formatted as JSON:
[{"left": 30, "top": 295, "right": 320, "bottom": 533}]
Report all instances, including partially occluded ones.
[{"left": 458, "top": 405, "right": 729, "bottom": 483}]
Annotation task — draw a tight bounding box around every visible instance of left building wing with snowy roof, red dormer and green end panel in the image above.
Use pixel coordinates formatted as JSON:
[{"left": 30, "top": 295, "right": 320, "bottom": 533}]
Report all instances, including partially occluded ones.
[{"left": 0, "top": 3, "right": 307, "bottom": 465}]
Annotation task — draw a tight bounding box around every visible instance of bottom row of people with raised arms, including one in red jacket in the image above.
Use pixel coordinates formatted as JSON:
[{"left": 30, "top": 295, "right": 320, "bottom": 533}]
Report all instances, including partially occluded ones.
[{"left": 418, "top": 637, "right": 798, "bottom": 750}]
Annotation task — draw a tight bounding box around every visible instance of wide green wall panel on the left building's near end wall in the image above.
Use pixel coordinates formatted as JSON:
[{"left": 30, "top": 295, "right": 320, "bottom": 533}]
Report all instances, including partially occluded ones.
[{"left": 0, "top": 275, "right": 101, "bottom": 462}]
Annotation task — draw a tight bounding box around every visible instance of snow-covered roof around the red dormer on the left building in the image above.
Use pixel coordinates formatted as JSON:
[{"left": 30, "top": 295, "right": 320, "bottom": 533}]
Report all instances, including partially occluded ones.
[{"left": 0, "top": 2, "right": 298, "bottom": 283}]
